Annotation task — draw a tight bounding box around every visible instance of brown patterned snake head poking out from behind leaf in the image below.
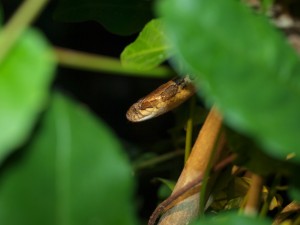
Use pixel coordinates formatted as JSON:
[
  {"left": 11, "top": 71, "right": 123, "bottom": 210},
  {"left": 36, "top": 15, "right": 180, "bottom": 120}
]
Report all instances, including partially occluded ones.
[{"left": 126, "top": 76, "right": 196, "bottom": 122}]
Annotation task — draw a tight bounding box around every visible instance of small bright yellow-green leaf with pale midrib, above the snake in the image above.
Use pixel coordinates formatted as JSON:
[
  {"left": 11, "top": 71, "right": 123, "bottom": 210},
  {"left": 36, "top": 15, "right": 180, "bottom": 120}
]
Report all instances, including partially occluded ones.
[{"left": 121, "top": 19, "right": 170, "bottom": 70}]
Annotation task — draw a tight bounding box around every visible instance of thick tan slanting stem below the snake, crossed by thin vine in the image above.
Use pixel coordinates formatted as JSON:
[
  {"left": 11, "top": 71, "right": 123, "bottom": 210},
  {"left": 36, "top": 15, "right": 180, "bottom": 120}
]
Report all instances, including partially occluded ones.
[{"left": 155, "top": 109, "right": 224, "bottom": 225}]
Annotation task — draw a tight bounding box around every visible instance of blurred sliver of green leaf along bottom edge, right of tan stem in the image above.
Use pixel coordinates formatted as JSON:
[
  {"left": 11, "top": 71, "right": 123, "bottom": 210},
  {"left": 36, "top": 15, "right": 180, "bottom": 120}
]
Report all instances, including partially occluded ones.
[{"left": 192, "top": 213, "right": 272, "bottom": 225}]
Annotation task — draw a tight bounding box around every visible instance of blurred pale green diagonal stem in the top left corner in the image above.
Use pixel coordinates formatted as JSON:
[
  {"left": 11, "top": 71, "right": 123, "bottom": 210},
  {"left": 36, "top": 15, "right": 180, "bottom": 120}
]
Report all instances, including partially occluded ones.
[{"left": 0, "top": 0, "right": 48, "bottom": 62}]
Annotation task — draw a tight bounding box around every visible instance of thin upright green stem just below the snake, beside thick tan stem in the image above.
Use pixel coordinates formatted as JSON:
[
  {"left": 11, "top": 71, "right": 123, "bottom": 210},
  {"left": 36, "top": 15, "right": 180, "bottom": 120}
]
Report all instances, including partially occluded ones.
[{"left": 184, "top": 96, "right": 196, "bottom": 162}]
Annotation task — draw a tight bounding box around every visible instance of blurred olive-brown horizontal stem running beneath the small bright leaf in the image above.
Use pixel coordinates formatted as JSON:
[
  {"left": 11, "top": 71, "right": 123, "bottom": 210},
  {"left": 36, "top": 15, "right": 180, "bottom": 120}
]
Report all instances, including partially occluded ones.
[{"left": 55, "top": 47, "right": 174, "bottom": 78}]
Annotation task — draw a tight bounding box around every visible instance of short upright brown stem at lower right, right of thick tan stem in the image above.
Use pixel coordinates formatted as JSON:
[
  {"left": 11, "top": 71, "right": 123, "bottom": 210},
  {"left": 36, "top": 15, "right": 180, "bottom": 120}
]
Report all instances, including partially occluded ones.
[{"left": 244, "top": 174, "right": 264, "bottom": 216}]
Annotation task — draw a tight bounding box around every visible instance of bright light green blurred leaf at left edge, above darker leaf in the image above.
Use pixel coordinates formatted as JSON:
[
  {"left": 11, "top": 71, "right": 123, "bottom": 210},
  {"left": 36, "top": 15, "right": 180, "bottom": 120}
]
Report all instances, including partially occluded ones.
[{"left": 0, "top": 30, "right": 55, "bottom": 163}]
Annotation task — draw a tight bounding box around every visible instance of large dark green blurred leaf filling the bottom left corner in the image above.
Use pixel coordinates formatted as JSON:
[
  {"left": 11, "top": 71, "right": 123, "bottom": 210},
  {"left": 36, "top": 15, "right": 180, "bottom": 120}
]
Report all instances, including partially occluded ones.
[{"left": 0, "top": 94, "right": 136, "bottom": 225}]
